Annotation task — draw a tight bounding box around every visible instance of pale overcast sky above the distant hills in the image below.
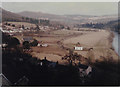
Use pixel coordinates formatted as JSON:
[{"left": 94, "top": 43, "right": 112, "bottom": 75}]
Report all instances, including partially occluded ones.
[{"left": 2, "top": 2, "right": 118, "bottom": 15}]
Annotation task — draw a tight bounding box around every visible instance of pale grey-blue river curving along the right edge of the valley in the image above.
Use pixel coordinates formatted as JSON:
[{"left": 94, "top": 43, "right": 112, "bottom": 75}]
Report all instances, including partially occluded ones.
[{"left": 113, "top": 32, "right": 120, "bottom": 56}]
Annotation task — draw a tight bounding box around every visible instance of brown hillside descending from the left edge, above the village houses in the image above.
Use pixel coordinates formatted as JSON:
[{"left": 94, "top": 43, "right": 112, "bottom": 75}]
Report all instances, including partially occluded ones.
[{"left": 0, "top": 8, "right": 49, "bottom": 24}]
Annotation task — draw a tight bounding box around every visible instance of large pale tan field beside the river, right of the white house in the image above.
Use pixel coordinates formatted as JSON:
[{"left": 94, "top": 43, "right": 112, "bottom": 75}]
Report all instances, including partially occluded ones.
[{"left": 64, "top": 30, "right": 118, "bottom": 62}]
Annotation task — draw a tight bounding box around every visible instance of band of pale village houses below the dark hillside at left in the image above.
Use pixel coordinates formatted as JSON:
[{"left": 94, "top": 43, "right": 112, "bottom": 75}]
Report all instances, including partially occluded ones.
[{"left": 0, "top": 22, "right": 68, "bottom": 34}]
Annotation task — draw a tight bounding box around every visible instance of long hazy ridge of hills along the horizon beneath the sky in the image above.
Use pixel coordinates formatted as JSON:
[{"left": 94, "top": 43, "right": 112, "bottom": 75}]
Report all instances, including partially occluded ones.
[{"left": 0, "top": 9, "right": 117, "bottom": 26}]
